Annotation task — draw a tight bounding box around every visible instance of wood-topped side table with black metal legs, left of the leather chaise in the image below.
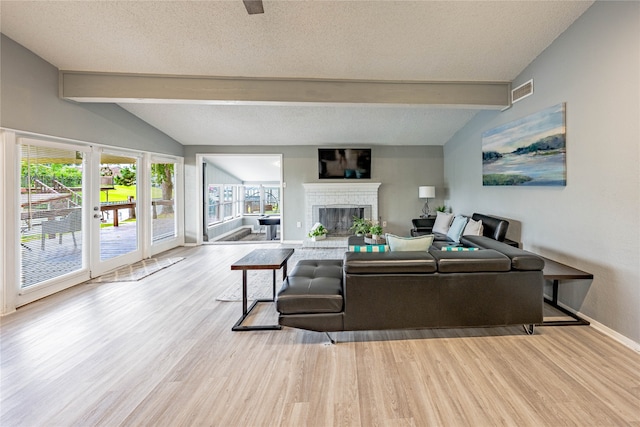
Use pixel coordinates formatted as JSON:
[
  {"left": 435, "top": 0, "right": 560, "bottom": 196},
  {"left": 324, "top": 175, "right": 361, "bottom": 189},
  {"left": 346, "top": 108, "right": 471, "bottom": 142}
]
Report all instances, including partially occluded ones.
[{"left": 231, "top": 248, "right": 294, "bottom": 331}]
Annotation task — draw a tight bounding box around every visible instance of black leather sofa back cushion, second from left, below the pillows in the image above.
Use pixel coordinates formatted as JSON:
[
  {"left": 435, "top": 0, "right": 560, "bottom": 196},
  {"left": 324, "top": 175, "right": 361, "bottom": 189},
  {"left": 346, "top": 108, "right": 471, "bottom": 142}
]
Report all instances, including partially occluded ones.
[{"left": 430, "top": 249, "right": 511, "bottom": 273}]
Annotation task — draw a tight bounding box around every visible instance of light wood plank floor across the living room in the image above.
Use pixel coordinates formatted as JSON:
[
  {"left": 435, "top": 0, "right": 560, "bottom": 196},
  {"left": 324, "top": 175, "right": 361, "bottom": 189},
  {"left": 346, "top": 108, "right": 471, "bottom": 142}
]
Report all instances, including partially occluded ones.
[{"left": 0, "top": 244, "right": 640, "bottom": 427}]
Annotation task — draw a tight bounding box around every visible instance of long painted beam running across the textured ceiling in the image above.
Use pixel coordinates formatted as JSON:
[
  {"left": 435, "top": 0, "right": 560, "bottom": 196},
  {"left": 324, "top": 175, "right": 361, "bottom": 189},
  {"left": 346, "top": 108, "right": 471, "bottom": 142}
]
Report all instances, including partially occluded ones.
[{"left": 59, "top": 71, "right": 511, "bottom": 109}]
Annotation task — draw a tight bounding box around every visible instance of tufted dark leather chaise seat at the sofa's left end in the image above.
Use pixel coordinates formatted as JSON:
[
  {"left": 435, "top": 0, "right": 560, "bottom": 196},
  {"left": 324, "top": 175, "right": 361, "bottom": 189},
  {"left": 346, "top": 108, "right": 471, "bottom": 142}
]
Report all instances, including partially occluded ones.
[{"left": 276, "top": 260, "right": 343, "bottom": 314}]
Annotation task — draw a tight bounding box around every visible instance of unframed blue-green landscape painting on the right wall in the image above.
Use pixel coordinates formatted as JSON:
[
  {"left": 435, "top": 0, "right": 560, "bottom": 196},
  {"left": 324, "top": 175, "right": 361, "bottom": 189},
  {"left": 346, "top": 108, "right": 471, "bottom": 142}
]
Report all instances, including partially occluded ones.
[{"left": 482, "top": 103, "right": 567, "bottom": 186}]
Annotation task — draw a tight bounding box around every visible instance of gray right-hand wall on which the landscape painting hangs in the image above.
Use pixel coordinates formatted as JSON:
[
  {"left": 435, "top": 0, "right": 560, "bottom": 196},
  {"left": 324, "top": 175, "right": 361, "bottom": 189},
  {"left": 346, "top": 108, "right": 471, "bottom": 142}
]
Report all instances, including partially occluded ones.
[{"left": 444, "top": 2, "right": 640, "bottom": 343}]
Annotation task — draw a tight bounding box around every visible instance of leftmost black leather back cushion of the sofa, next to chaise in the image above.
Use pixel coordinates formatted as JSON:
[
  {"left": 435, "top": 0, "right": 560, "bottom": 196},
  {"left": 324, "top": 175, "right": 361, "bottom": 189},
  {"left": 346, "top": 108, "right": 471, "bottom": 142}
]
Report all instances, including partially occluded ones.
[{"left": 344, "top": 251, "right": 437, "bottom": 274}]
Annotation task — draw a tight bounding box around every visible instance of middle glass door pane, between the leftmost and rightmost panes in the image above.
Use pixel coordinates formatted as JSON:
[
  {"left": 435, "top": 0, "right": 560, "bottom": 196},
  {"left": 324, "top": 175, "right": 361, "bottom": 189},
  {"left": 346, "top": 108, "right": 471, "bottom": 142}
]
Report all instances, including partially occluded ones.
[{"left": 91, "top": 150, "right": 142, "bottom": 277}]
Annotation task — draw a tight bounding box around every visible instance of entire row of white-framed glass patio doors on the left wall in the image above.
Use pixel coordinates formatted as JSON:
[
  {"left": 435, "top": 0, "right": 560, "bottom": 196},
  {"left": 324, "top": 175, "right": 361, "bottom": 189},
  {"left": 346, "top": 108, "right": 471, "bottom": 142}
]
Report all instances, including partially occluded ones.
[{"left": 0, "top": 129, "right": 184, "bottom": 313}]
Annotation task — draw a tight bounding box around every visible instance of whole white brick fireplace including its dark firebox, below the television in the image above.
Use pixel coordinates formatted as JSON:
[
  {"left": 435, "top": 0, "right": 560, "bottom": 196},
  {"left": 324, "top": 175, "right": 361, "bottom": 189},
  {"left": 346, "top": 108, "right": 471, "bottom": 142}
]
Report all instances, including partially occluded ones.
[{"left": 302, "top": 182, "right": 380, "bottom": 237}]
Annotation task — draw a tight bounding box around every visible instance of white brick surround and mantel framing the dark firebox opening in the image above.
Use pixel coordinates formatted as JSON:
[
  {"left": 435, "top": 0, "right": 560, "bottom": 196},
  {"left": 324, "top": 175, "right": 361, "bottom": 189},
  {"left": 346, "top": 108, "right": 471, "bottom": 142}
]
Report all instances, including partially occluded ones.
[{"left": 302, "top": 182, "right": 381, "bottom": 234}]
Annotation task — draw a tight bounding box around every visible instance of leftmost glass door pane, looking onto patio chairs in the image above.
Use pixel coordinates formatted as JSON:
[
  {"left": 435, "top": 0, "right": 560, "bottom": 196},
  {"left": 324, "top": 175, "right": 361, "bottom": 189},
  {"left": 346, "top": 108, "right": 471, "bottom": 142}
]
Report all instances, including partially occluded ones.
[{"left": 18, "top": 138, "right": 88, "bottom": 291}]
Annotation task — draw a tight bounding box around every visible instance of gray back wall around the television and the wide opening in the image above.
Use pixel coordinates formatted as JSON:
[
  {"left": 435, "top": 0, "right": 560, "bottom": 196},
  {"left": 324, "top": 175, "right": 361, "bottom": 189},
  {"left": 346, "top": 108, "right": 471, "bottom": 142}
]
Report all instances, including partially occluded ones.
[{"left": 185, "top": 143, "right": 444, "bottom": 242}]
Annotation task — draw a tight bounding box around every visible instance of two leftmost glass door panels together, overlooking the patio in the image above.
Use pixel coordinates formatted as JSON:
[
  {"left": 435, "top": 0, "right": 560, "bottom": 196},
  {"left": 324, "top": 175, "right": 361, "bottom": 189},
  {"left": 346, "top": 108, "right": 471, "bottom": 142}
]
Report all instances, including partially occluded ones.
[{"left": 15, "top": 138, "right": 148, "bottom": 305}]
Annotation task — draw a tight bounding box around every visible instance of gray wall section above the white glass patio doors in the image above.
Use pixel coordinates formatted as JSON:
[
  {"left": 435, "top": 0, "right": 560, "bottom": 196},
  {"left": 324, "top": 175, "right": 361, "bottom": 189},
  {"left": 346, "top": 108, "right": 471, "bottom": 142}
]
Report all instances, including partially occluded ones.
[{"left": 0, "top": 34, "right": 183, "bottom": 156}]
